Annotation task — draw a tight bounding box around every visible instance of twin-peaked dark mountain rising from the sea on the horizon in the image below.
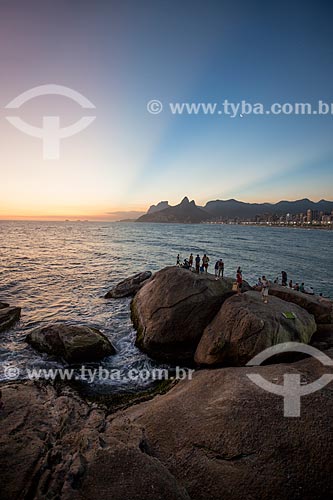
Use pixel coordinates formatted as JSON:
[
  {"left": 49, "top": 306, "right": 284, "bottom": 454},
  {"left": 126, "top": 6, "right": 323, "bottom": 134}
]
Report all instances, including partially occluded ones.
[{"left": 137, "top": 196, "right": 211, "bottom": 224}]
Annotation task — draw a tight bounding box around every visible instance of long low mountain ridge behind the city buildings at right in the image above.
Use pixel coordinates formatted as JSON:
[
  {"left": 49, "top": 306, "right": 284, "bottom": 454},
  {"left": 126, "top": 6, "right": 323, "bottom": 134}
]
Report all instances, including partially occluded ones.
[{"left": 204, "top": 198, "right": 333, "bottom": 218}]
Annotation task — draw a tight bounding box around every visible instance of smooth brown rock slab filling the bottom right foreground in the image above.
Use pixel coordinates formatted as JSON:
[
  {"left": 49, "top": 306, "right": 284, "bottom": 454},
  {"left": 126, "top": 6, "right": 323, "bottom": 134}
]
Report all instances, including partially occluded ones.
[{"left": 106, "top": 351, "right": 333, "bottom": 500}]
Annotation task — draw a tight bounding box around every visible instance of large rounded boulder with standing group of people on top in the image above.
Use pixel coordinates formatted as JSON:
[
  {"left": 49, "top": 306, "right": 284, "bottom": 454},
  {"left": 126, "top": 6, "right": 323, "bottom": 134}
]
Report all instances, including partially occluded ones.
[{"left": 131, "top": 267, "right": 237, "bottom": 362}]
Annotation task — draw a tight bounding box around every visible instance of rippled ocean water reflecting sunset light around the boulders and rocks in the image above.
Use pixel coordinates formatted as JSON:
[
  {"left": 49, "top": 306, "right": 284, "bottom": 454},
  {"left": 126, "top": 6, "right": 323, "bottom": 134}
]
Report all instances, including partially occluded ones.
[{"left": 0, "top": 221, "right": 333, "bottom": 390}]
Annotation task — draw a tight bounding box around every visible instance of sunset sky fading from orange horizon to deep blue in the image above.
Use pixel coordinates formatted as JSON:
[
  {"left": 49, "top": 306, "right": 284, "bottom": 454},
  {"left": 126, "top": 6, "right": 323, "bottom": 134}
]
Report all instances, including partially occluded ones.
[{"left": 0, "top": 0, "right": 333, "bottom": 220}]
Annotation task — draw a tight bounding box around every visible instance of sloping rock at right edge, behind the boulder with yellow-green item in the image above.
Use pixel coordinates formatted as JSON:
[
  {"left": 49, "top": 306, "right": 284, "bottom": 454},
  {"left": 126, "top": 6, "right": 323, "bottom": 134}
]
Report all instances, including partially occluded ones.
[{"left": 269, "top": 285, "right": 333, "bottom": 324}]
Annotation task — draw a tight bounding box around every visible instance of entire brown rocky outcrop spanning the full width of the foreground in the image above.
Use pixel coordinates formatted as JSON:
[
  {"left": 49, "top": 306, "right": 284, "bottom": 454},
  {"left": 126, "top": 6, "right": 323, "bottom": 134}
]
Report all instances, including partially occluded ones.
[{"left": 0, "top": 351, "right": 333, "bottom": 500}]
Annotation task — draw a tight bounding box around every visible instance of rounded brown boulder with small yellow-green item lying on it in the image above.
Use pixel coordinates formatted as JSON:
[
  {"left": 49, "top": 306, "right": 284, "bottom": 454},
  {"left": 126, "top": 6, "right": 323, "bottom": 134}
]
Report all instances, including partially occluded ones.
[{"left": 194, "top": 291, "right": 316, "bottom": 366}]
